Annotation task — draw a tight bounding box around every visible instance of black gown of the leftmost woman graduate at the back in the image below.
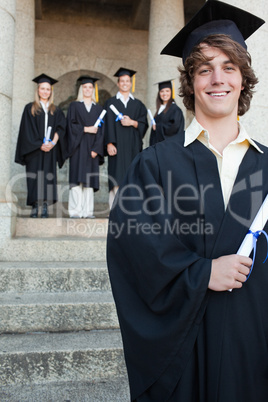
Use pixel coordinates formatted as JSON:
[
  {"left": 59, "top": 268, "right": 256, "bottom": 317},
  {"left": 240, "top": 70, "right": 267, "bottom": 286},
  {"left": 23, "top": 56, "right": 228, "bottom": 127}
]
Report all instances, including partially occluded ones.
[{"left": 15, "top": 103, "right": 66, "bottom": 205}]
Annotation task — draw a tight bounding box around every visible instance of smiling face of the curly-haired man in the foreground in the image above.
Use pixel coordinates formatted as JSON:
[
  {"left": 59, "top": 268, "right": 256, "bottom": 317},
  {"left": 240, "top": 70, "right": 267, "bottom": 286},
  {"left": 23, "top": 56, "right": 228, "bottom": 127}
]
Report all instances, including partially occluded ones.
[{"left": 193, "top": 45, "right": 243, "bottom": 122}]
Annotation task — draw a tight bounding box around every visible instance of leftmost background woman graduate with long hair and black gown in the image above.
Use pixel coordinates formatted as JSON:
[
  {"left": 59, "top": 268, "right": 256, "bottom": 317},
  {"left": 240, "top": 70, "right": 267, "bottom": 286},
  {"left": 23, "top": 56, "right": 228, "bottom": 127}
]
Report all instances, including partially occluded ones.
[{"left": 15, "top": 74, "right": 66, "bottom": 218}]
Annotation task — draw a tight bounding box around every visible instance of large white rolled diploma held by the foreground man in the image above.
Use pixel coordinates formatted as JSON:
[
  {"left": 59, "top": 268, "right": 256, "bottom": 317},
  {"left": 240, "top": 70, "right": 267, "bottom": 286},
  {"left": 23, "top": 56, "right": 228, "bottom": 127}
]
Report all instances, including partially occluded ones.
[{"left": 229, "top": 194, "right": 268, "bottom": 292}]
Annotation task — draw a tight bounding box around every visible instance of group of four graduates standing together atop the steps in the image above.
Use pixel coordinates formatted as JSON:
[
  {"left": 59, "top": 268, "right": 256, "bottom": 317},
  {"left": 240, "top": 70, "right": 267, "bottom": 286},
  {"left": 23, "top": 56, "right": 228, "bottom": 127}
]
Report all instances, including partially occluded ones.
[{"left": 15, "top": 67, "right": 184, "bottom": 218}]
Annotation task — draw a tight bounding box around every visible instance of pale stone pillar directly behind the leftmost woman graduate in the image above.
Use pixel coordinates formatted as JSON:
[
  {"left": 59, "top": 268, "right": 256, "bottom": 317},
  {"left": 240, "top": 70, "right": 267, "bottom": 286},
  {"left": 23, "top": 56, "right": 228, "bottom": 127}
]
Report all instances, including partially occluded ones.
[{"left": 11, "top": 0, "right": 35, "bottom": 206}]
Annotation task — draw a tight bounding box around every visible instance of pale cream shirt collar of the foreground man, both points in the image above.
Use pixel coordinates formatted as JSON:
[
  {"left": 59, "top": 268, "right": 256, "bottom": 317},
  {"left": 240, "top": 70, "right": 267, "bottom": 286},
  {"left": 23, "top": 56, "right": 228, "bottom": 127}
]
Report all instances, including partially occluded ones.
[{"left": 184, "top": 117, "right": 263, "bottom": 153}]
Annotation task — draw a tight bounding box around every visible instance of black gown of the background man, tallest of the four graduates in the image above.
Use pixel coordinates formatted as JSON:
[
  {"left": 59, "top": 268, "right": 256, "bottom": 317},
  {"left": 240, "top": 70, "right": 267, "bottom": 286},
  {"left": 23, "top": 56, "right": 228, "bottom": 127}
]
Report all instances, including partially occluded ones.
[{"left": 105, "top": 96, "right": 148, "bottom": 190}]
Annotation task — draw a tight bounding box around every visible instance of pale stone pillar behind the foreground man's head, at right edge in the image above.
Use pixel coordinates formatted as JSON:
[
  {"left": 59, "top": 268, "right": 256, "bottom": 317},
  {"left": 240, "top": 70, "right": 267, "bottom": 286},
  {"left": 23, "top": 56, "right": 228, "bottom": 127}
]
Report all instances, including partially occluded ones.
[{"left": 224, "top": 0, "right": 268, "bottom": 146}]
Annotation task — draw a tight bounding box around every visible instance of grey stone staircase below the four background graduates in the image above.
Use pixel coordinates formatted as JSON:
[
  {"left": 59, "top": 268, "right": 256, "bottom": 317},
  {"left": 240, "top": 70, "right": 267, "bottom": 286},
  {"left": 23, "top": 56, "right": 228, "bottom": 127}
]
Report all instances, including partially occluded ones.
[{"left": 0, "top": 212, "right": 130, "bottom": 402}]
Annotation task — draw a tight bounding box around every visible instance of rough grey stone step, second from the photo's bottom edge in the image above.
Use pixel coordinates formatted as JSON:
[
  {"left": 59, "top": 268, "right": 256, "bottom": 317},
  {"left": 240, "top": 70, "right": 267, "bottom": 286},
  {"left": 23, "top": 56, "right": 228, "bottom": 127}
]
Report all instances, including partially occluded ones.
[{"left": 0, "top": 330, "right": 129, "bottom": 401}]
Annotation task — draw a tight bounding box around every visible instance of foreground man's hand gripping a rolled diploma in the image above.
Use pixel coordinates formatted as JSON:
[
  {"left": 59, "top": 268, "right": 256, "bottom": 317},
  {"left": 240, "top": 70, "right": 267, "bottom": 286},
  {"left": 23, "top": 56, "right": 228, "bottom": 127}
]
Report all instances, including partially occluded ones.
[{"left": 208, "top": 254, "right": 252, "bottom": 292}]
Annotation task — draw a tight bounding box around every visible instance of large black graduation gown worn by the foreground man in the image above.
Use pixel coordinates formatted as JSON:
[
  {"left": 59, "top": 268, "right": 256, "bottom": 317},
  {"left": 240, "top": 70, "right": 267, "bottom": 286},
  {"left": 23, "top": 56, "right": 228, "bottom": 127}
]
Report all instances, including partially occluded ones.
[{"left": 107, "top": 136, "right": 268, "bottom": 402}]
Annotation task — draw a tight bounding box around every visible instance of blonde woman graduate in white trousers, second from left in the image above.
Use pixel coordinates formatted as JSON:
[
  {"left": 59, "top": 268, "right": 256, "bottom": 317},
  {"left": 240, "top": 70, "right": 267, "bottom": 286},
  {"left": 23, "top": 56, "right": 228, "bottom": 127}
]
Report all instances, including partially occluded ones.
[{"left": 67, "top": 76, "right": 104, "bottom": 218}]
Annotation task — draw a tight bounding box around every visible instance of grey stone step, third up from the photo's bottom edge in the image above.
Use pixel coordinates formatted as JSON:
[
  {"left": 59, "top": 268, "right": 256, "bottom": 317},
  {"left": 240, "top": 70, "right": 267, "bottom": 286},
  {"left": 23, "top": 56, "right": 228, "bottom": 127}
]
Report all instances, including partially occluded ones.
[{"left": 0, "top": 291, "right": 119, "bottom": 334}]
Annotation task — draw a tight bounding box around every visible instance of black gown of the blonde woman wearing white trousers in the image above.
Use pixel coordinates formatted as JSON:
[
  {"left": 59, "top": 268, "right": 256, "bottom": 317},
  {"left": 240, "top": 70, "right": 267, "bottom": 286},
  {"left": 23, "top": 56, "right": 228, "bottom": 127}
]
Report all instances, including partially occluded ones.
[{"left": 67, "top": 101, "right": 104, "bottom": 191}]
